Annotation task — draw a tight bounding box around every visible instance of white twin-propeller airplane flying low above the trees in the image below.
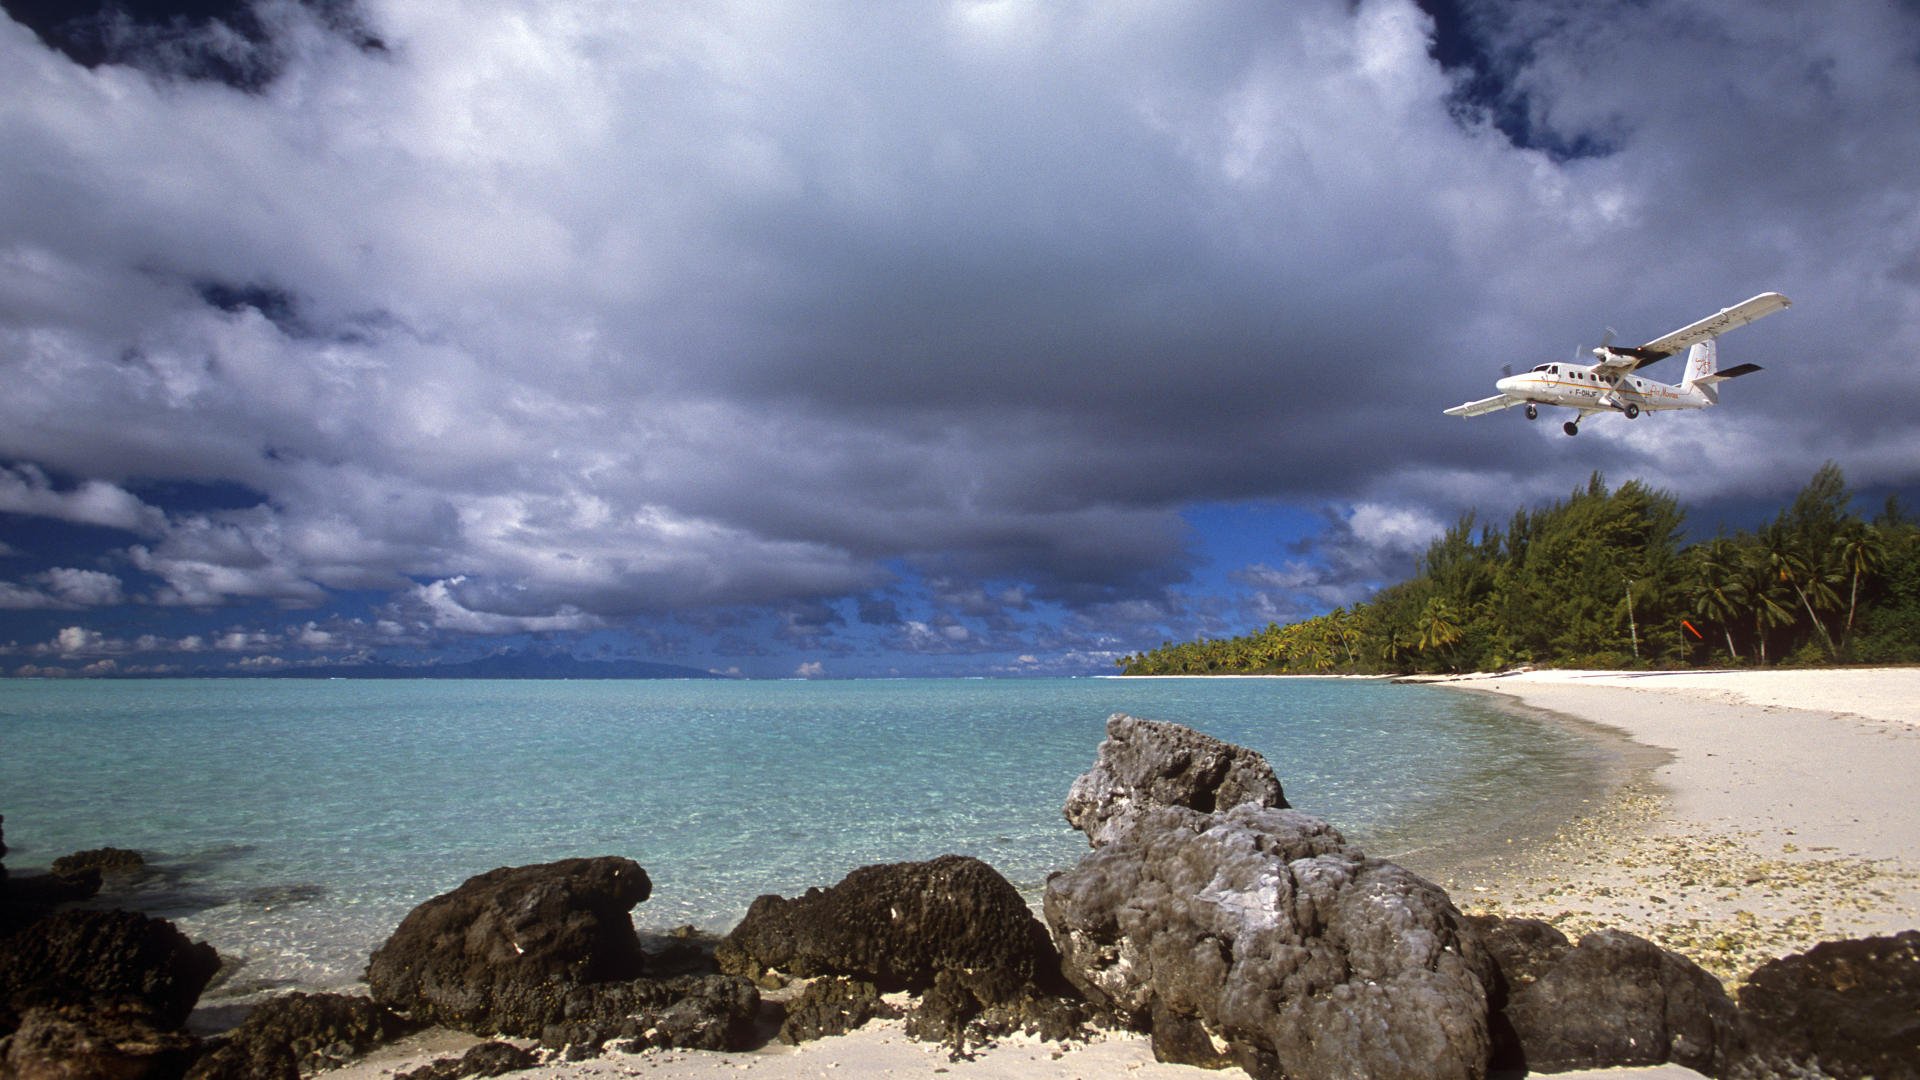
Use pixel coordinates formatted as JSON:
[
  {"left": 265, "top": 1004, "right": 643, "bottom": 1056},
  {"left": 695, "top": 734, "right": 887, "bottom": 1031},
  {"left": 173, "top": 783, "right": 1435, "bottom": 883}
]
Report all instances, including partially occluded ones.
[{"left": 1446, "top": 292, "right": 1793, "bottom": 434}]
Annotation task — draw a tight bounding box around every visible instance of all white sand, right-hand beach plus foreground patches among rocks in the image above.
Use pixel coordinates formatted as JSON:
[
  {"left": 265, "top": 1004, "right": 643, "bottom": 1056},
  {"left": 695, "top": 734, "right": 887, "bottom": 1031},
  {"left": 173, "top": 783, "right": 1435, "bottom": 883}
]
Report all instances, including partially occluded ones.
[{"left": 330, "top": 669, "right": 1920, "bottom": 1080}]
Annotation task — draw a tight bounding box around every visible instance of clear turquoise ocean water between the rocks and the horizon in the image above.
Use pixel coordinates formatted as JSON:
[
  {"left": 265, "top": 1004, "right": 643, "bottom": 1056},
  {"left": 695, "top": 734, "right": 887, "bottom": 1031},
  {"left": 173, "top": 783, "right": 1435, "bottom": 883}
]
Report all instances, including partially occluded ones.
[{"left": 0, "top": 678, "right": 1596, "bottom": 997}]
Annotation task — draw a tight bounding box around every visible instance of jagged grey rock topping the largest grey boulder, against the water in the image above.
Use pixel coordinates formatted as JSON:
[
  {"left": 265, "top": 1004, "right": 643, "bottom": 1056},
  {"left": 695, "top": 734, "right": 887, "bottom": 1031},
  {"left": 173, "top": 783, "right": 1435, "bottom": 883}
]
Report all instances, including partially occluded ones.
[{"left": 1066, "top": 713, "right": 1286, "bottom": 847}]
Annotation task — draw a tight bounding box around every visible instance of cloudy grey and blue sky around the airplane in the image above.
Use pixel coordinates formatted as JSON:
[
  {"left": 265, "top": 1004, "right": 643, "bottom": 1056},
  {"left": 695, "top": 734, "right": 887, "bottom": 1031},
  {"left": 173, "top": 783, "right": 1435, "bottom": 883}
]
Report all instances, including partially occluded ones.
[{"left": 0, "top": 0, "right": 1920, "bottom": 676}]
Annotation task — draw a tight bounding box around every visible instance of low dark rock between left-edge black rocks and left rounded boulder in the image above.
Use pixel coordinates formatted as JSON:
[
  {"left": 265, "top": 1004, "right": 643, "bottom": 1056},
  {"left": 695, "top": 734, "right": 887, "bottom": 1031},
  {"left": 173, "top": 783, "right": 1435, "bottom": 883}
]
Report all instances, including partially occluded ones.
[{"left": 188, "top": 994, "right": 420, "bottom": 1080}]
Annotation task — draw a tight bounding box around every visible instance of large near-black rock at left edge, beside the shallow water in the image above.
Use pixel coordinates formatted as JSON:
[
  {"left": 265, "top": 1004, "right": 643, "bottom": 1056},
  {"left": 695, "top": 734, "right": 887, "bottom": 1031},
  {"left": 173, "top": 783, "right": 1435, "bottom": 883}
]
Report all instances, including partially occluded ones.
[{"left": 0, "top": 911, "right": 221, "bottom": 1030}]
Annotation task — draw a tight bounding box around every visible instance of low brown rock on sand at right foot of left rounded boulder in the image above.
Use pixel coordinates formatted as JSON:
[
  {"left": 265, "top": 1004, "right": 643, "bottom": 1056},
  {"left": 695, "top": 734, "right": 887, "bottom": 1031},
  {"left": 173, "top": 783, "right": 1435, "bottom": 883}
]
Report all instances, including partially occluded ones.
[{"left": 540, "top": 974, "right": 760, "bottom": 1057}]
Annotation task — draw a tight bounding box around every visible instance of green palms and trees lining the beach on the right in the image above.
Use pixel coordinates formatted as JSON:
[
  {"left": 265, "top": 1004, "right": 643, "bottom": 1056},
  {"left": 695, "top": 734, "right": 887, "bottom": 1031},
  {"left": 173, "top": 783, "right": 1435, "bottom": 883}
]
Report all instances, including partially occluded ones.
[{"left": 1119, "top": 463, "right": 1920, "bottom": 675}]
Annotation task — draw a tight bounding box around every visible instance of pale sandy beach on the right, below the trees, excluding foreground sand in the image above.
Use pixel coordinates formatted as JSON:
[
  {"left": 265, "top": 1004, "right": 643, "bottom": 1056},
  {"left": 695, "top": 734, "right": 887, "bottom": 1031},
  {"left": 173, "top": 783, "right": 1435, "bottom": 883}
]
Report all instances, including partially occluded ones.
[{"left": 1436, "top": 669, "right": 1920, "bottom": 990}]
